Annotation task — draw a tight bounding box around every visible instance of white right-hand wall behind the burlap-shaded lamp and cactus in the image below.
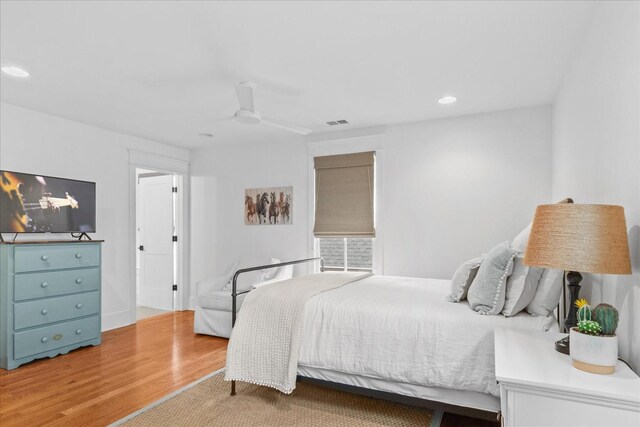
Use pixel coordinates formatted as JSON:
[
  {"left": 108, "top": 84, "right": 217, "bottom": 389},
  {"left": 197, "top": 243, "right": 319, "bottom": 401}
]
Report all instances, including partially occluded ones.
[{"left": 552, "top": 2, "right": 640, "bottom": 373}]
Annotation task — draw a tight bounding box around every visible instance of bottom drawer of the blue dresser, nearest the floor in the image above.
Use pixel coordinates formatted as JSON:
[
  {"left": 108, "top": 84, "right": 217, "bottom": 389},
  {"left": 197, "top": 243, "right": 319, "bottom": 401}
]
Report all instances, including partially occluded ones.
[{"left": 13, "top": 316, "right": 100, "bottom": 359}]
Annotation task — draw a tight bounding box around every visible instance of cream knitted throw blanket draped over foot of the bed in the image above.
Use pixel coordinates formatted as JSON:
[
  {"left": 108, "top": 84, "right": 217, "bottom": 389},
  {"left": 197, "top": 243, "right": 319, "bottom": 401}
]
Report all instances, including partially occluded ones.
[{"left": 225, "top": 273, "right": 371, "bottom": 394}]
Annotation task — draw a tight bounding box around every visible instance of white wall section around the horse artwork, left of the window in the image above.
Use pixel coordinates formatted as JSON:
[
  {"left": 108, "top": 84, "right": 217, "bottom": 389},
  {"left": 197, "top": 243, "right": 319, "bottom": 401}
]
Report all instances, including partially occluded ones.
[{"left": 191, "top": 137, "right": 307, "bottom": 306}]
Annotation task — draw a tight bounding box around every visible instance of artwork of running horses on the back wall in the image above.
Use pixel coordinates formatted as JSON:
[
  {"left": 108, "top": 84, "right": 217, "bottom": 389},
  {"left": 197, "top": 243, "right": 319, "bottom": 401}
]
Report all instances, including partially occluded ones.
[{"left": 244, "top": 187, "right": 293, "bottom": 225}]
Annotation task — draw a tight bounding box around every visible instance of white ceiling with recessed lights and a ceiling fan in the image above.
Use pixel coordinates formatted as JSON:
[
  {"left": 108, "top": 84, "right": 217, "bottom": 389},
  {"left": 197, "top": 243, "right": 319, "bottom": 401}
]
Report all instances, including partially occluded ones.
[{"left": 0, "top": 1, "right": 594, "bottom": 148}]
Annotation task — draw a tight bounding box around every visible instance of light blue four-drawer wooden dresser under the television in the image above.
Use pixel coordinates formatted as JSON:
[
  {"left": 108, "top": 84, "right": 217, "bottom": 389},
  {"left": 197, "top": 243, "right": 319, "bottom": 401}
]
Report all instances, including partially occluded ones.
[{"left": 0, "top": 241, "right": 102, "bottom": 369}]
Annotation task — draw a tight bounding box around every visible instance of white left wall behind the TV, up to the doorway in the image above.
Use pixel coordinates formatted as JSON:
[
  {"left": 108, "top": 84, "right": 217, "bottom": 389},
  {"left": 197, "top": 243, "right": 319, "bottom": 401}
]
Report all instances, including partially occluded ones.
[{"left": 0, "top": 103, "right": 189, "bottom": 330}]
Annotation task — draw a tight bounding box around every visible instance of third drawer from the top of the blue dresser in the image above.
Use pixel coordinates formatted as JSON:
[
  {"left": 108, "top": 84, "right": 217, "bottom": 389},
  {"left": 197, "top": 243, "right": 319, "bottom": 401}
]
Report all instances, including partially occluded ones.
[{"left": 13, "top": 292, "right": 100, "bottom": 330}]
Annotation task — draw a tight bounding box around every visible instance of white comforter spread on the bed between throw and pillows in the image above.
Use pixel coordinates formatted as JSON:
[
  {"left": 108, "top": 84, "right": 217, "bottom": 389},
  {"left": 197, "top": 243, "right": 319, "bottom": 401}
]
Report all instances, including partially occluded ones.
[{"left": 298, "top": 276, "right": 556, "bottom": 396}]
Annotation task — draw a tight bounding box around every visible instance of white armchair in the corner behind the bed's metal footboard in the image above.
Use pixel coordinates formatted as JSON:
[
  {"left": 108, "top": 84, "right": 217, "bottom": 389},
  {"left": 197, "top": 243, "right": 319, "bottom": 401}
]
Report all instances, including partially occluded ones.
[{"left": 193, "top": 259, "right": 293, "bottom": 338}]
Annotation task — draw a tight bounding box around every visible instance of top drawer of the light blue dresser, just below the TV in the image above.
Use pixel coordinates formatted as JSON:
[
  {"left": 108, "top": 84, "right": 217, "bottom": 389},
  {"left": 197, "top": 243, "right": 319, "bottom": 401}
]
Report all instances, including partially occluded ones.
[{"left": 13, "top": 243, "right": 100, "bottom": 273}]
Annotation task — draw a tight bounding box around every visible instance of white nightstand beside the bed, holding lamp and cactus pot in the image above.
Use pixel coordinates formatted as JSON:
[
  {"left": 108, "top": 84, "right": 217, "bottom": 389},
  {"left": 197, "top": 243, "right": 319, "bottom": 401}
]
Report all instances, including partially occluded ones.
[{"left": 495, "top": 328, "right": 640, "bottom": 427}]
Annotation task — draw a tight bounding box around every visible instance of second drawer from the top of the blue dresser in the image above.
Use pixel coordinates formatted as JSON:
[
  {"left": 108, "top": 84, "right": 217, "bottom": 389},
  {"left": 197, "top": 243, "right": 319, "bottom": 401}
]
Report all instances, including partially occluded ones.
[{"left": 13, "top": 268, "right": 100, "bottom": 301}]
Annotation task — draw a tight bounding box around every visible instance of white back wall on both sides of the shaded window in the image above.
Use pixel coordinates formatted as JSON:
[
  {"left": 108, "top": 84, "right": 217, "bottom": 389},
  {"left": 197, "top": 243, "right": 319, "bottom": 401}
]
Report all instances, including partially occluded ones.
[{"left": 191, "top": 107, "right": 551, "bottom": 302}]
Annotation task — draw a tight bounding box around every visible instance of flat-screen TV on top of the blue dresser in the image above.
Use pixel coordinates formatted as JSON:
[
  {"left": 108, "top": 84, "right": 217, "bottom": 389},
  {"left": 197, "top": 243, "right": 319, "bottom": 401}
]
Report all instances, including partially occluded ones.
[{"left": 0, "top": 170, "right": 96, "bottom": 233}]
